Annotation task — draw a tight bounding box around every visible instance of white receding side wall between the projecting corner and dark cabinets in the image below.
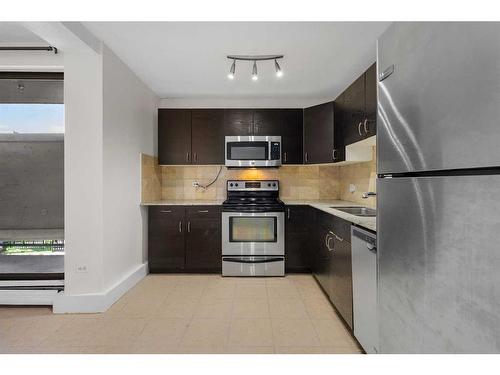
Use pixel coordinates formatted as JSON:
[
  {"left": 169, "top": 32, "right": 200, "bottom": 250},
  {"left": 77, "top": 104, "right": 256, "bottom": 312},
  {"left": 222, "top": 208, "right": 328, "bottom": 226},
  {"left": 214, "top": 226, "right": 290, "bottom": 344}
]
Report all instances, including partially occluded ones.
[{"left": 102, "top": 46, "right": 158, "bottom": 287}]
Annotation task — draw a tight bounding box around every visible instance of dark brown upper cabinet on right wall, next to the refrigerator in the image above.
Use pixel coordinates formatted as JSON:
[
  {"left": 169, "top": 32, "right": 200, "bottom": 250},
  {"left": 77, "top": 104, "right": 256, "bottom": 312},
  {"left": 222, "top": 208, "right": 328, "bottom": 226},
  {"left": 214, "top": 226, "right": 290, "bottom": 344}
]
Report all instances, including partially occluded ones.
[{"left": 335, "top": 64, "right": 377, "bottom": 145}]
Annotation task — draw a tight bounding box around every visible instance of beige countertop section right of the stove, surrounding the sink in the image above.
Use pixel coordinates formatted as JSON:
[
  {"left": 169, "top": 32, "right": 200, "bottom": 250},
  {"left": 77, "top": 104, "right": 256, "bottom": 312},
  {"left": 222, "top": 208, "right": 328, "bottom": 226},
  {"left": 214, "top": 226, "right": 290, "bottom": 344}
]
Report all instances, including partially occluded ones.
[{"left": 282, "top": 199, "right": 377, "bottom": 232}]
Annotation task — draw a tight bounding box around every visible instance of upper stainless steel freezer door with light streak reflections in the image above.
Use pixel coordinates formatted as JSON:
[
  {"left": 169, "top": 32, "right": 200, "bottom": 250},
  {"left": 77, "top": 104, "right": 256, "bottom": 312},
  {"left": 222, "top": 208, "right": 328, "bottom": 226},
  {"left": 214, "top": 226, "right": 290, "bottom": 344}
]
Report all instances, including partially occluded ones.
[{"left": 377, "top": 22, "right": 500, "bottom": 173}]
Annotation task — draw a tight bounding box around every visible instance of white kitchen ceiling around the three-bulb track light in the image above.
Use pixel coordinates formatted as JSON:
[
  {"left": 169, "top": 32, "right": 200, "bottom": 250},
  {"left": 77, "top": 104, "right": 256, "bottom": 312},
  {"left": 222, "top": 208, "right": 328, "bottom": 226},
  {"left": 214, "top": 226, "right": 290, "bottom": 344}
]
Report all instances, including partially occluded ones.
[{"left": 84, "top": 22, "right": 389, "bottom": 98}]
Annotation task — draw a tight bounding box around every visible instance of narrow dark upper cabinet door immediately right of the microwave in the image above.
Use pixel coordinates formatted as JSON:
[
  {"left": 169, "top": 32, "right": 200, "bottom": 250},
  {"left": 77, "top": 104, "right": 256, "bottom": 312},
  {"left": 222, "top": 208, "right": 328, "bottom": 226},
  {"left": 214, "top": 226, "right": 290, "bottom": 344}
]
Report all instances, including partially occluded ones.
[{"left": 281, "top": 109, "right": 304, "bottom": 164}]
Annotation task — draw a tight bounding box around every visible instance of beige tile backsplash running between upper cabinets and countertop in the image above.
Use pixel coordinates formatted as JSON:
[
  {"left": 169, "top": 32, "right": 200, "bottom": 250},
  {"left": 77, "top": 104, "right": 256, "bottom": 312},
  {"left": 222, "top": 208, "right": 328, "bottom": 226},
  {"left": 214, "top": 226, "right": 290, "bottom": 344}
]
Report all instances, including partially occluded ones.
[{"left": 141, "top": 146, "right": 376, "bottom": 206}]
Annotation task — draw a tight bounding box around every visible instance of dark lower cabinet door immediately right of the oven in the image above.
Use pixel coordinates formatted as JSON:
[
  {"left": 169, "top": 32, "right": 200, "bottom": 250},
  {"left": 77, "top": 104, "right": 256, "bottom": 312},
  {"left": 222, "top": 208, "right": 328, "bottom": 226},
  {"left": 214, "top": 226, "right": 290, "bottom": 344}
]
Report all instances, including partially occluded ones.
[{"left": 285, "top": 206, "right": 311, "bottom": 272}]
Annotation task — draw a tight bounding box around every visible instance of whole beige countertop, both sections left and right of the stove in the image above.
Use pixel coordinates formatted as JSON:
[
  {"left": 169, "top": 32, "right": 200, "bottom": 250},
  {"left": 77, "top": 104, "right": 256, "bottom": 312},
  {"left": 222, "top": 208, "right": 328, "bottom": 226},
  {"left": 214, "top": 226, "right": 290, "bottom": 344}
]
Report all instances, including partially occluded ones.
[{"left": 141, "top": 199, "right": 377, "bottom": 231}]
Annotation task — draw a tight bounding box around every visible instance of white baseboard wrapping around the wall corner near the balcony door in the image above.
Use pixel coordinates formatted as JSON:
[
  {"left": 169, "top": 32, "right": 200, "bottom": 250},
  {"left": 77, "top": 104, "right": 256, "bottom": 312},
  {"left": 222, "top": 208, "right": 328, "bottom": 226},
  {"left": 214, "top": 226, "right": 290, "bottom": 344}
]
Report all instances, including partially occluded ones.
[{"left": 53, "top": 263, "right": 148, "bottom": 314}]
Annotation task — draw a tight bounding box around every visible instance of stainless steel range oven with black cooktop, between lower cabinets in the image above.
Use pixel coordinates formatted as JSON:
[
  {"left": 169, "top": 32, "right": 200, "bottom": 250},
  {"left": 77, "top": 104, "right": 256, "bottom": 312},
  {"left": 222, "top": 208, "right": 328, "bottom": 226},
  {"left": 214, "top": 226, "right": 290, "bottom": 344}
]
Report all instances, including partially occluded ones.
[{"left": 222, "top": 180, "right": 285, "bottom": 276}]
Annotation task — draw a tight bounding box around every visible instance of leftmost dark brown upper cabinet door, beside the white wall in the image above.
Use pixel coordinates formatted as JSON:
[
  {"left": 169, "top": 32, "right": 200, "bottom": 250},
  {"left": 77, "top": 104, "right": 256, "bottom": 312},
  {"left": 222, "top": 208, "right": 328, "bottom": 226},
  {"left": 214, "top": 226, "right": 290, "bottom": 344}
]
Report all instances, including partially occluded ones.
[{"left": 158, "top": 108, "right": 191, "bottom": 164}]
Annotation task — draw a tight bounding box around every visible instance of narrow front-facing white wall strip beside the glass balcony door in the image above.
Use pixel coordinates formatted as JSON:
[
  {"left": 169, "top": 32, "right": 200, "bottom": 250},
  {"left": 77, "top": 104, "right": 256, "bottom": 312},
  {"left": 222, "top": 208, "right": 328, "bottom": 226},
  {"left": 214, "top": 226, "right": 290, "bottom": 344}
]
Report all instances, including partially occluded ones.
[{"left": 64, "top": 41, "right": 103, "bottom": 295}]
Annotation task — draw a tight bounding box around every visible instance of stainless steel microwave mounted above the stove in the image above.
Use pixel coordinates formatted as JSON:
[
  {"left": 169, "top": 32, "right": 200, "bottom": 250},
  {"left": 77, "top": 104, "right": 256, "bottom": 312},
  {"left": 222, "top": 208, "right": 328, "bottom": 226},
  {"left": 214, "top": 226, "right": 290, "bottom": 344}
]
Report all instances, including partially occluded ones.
[{"left": 225, "top": 135, "right": 281, "bottom": 168}]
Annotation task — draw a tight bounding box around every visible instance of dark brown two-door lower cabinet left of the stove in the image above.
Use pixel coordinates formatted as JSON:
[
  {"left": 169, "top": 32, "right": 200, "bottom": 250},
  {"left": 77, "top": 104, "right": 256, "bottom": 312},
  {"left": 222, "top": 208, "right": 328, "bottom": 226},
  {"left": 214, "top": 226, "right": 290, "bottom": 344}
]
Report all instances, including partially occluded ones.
[{"left": 148, "top": 206, "right": 222, "bottom": 273}]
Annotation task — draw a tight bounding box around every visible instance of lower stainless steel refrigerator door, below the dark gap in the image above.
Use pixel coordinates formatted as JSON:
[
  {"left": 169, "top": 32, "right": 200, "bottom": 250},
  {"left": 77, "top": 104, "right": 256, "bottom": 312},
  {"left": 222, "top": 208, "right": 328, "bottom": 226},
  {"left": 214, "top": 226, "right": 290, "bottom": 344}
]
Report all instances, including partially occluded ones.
[{"left": 377, "top": 175, "right": 500, "bottom": 353}]
